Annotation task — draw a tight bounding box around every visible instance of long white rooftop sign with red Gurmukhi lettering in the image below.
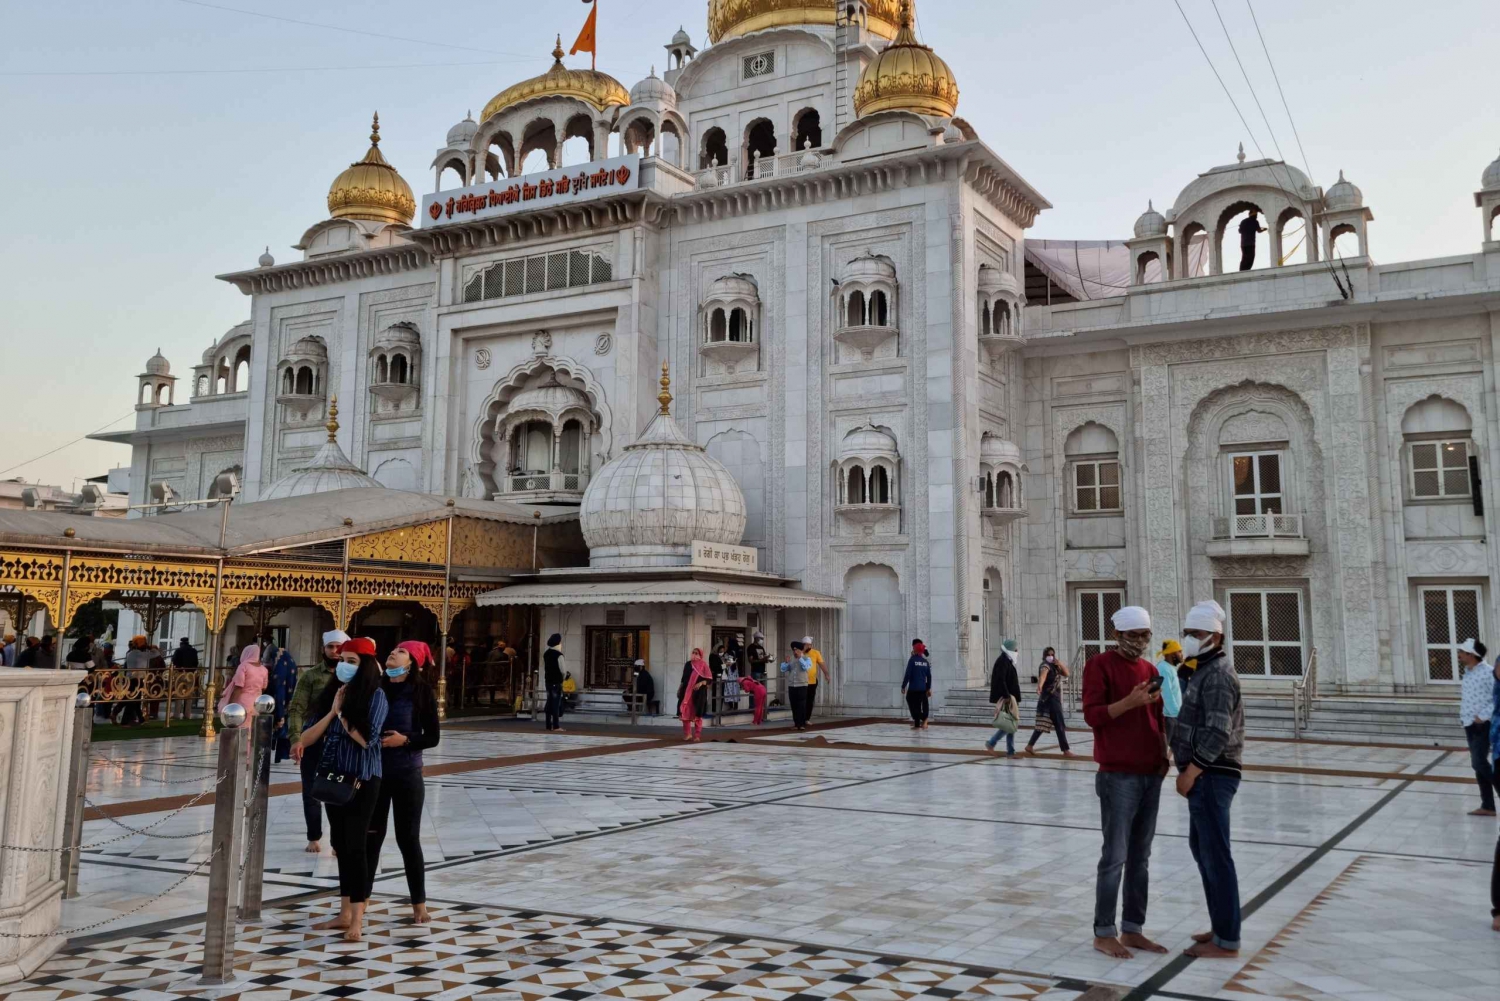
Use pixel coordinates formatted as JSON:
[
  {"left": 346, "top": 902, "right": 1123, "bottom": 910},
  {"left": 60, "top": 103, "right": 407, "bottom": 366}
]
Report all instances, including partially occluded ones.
[{"left": 422, "top": 153, "right": 641, "bottom": 230}]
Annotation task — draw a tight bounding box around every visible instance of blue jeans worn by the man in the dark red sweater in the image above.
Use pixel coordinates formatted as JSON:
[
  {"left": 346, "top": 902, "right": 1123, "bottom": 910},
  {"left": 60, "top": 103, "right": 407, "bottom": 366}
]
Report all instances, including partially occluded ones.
[{"left": 1094, "top": 771, "right": 1163, "bottom": 938}]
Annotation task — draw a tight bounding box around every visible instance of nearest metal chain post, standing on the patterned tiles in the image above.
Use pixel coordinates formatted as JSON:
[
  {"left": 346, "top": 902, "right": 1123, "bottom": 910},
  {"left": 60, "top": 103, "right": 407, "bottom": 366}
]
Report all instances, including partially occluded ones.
[{"left": 198, "top": 702, "right": 246, "bottom": 987}]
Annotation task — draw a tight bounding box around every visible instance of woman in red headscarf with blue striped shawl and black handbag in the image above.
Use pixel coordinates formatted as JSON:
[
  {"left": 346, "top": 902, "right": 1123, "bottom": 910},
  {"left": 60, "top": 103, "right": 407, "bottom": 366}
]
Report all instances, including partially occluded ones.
[{"left": 291, "top": 636, "right": 390, "bottom": 942}]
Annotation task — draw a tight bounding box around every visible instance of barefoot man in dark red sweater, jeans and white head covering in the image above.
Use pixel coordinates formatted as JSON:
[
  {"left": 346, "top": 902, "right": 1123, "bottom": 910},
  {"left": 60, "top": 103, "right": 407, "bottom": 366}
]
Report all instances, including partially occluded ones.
[{"left": 1083, "top": 605, "right": 1167, "bottom": 959}]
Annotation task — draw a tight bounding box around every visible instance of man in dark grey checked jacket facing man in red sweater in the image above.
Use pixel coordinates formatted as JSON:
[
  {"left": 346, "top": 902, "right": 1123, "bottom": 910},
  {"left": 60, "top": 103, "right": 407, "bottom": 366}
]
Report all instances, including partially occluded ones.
[{"left": 1172, "top": 602, "right": 1245, "bottom": 959}]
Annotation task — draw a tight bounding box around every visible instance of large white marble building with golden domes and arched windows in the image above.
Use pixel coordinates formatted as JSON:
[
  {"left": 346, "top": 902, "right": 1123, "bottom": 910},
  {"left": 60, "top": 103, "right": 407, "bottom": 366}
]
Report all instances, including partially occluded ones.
[{"left": 101, "top": 0, "right": 1500, "bottom": 711}]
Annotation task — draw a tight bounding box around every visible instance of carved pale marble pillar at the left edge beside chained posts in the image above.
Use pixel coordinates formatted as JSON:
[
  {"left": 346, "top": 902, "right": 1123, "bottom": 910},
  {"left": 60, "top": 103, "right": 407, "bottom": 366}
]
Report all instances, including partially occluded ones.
[{"left": 0, "top": 668, "right": 84, "bottom": 983}]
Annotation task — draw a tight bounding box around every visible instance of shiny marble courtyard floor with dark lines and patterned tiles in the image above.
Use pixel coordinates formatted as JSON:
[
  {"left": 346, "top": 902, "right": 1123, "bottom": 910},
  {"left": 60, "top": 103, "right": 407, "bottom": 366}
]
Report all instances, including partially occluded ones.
[{"left": 14, "top": 722, "right": 1500, "bottom": 1001}]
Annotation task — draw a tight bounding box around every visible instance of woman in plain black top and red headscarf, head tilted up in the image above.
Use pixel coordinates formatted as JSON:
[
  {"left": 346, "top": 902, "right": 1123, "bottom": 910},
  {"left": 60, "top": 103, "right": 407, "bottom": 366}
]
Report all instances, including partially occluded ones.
[{"left": 365, "top": 639, "right": 438, "bottom": 924}]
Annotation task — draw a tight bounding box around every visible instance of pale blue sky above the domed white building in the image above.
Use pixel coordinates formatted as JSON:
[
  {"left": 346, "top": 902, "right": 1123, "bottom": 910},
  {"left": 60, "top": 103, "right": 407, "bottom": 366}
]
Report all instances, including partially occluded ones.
[{"left": 0, "top": 0, "right": 1500, "bottom": 485}]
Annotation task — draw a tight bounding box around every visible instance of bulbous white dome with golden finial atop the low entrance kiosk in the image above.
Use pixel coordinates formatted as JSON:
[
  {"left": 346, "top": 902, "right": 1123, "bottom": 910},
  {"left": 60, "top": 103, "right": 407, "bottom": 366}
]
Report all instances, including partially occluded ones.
[{"left": 579, "top": 369, "right": 746, "bottom": 567}]
